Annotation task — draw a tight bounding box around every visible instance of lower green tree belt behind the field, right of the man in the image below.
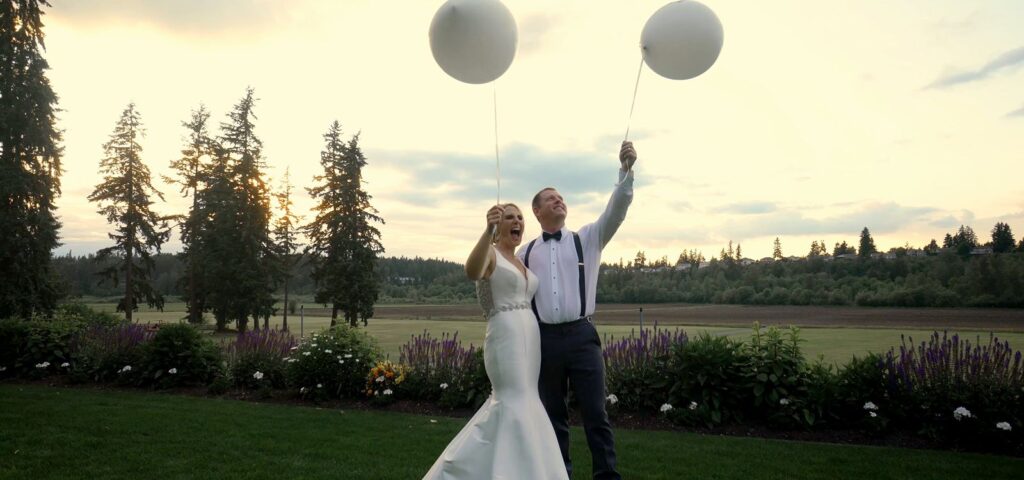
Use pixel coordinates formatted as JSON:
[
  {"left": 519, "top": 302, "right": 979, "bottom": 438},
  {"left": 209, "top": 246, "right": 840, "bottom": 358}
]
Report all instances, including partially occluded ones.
[{"left": 597, "top": 251, "right": 1024, "bottom": 308}]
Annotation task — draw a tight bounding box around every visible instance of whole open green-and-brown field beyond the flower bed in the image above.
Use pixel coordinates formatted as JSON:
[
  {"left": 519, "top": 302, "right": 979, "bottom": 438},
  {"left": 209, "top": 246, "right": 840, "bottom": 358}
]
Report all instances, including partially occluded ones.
[{"left": 79, "top": 303, "right": 1024, "bottom": 364}]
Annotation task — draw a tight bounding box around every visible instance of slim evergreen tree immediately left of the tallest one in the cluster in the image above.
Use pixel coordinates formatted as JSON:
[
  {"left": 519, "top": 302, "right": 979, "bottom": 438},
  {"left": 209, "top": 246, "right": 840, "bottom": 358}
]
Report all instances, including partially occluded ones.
[{"left": 164, "top": 105, "right": 213, "bottom": 324}]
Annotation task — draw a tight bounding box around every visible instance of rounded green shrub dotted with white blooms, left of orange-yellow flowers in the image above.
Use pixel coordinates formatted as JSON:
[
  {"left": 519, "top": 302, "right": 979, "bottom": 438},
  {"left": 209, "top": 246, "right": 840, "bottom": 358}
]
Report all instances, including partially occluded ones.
[{"left": 287, "top": 325, "right": 380, "bottom": 400}]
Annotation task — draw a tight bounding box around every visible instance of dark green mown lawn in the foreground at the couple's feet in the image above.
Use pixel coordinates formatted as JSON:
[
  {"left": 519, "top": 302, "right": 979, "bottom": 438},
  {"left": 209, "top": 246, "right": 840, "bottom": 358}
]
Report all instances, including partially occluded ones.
[{"left": 0, "top": 384, "right": 1024, "bottom": 480}]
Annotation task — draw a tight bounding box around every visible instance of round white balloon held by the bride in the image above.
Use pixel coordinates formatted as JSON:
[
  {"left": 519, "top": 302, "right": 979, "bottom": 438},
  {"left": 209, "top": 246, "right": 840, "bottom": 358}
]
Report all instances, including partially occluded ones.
[{"left": 430, "top": 0, "right": 518, "bottom": 84}]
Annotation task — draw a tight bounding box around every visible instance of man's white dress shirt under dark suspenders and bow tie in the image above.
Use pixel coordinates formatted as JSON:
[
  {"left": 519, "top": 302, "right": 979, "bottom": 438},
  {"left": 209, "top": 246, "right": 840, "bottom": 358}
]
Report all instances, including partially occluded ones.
[{"left": 516, "top": 169, "right": 633, "bottom": 323}]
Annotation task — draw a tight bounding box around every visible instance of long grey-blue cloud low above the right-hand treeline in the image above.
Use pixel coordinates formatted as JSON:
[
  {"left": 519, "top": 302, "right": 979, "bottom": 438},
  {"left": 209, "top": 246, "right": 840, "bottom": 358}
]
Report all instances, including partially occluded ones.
[{"left": 722, "top": 203, "right": 943, "bottom": 238}]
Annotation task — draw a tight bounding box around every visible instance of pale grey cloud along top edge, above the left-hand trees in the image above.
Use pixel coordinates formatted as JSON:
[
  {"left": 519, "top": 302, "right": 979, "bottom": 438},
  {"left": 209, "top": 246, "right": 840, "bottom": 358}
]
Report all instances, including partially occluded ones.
[{"left": 47, "top": 0, "right": 290, "bottom": 35}]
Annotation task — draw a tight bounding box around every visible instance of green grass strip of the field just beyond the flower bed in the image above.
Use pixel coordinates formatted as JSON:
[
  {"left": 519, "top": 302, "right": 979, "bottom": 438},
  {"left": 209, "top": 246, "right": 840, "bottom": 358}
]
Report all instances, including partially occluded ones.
[{"left": 81, "top": 302, "right": 1024, "bottom": 364}]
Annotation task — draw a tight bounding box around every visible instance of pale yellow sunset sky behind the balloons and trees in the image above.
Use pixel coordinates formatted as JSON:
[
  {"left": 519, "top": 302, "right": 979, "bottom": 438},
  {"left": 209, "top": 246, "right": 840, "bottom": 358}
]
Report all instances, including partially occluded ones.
[{"left": 37, "top": 0, "right": 1024, "bottom": 262}]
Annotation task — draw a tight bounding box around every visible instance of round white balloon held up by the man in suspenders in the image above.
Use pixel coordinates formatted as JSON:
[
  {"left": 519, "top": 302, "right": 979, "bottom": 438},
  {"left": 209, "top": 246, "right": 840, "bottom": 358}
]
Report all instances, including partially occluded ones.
[{"left": 640, "top": 0, "right": 723, "bottom": 80}]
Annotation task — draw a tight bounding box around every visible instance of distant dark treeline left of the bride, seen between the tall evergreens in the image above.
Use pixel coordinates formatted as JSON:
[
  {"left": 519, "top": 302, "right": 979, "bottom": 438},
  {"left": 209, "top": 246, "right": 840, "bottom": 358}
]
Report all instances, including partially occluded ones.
[{"left": 53, "top": 254, "right": 476, "bottom": 303}]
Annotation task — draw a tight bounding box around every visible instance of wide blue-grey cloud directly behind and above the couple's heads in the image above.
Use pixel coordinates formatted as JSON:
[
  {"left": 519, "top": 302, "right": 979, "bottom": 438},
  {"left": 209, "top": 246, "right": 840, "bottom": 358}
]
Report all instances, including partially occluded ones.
[{"left": 368, "top": 143, "right": 618, "bottom": 207}]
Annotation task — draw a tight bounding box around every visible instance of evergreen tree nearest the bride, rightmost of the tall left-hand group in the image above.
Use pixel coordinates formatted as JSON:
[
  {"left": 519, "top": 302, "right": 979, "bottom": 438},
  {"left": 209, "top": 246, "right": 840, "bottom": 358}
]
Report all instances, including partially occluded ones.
[{"left": 305, "top": 121, "right": 384, "bottom": 326}]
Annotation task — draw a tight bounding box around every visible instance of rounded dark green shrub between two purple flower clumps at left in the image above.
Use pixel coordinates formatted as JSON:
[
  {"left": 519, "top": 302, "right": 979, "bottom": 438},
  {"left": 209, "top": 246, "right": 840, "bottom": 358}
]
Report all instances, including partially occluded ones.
[{"left": 139, "top": 323, "right": 223, "bottom": 388}]
